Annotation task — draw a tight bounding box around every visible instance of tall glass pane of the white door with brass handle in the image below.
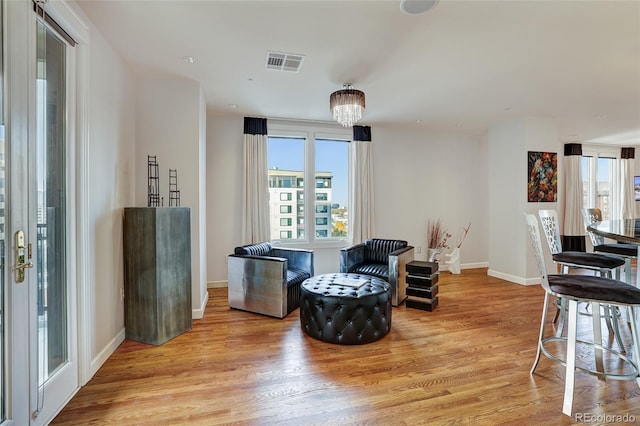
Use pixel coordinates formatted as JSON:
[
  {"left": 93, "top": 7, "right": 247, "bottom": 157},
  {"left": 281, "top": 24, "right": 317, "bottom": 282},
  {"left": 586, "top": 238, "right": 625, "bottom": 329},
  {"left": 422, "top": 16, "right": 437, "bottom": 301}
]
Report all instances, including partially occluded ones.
[{"left": 32, "top": 14, "right": 69, "bottom": 420}]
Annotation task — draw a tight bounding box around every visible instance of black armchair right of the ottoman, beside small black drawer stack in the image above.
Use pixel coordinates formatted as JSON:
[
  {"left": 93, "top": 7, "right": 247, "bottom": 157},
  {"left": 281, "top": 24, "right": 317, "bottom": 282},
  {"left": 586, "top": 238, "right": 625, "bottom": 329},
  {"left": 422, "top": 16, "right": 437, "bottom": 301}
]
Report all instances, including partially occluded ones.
[{"left": 340, "top": 238, "right": 413, "bottom": 306}]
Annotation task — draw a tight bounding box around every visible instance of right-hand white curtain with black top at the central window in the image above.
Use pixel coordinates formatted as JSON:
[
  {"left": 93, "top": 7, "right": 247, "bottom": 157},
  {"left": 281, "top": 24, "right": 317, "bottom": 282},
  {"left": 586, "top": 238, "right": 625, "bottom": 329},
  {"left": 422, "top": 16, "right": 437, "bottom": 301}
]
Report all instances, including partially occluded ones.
[{"left": 349, "top": 126, "right": 374, "bottom": 244}]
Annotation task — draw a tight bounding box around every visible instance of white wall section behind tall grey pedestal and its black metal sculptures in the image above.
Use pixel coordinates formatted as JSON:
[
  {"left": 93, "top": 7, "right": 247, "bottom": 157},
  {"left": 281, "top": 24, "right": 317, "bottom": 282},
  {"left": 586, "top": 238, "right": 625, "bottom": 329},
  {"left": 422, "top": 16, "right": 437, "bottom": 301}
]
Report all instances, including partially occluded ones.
[{"left": 135, "top": 72, "right": 208, "bottom": 318}]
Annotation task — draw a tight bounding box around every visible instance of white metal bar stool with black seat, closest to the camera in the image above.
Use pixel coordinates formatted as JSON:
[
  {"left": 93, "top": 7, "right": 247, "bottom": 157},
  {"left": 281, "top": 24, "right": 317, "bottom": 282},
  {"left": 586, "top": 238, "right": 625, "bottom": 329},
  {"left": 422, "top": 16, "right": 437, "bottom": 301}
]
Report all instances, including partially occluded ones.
[{"left": 525, "top": 214, "right": 640, "bottom": 416}]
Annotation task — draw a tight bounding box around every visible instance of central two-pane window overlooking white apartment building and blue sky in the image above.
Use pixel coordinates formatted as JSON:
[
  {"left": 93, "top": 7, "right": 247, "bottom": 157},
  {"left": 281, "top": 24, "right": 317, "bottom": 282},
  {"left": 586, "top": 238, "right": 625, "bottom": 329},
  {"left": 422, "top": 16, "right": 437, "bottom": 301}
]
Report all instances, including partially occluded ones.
[{"left": 267, "top": 124, "right": 351, "bottom": 243}]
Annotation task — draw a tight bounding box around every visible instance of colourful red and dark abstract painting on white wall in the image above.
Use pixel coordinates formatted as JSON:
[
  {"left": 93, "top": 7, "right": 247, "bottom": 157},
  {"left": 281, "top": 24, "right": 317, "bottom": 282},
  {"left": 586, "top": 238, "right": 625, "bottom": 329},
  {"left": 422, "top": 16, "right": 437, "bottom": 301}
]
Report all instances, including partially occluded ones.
[{"left": 527, "top": 151, "right": 558, "bottom": 203}]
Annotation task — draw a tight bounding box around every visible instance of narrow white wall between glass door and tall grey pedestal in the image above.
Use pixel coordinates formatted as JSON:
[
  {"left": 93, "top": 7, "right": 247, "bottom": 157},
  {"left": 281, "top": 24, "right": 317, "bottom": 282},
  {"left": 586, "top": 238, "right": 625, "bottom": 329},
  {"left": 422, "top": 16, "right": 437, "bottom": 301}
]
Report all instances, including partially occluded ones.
[{"left": 85, "top": 19, "right": 136, "bottom": 375}]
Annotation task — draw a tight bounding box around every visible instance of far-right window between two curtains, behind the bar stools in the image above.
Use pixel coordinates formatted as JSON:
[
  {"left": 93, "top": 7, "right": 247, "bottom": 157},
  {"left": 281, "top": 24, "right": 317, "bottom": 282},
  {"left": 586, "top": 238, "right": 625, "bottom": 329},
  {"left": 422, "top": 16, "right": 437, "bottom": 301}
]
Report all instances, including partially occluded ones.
[{"left": 582, "top": 148, "right": 622, "bottom": 220}]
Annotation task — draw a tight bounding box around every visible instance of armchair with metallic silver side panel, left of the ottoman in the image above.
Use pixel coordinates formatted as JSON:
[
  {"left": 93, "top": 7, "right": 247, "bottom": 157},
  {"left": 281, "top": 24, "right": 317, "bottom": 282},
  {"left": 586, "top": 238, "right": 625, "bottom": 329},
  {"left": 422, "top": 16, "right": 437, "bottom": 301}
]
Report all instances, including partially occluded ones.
[{"left": 227, "top": 243, "right": 313, "bottom": 318}]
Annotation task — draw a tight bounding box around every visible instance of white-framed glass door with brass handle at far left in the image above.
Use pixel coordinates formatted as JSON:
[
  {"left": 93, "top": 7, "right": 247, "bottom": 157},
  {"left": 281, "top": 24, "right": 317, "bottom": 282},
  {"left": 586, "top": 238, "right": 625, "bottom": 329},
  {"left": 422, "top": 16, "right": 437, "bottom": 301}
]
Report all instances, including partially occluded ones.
[{"left": 5, "top": 1, "right": 79, "bottom": 425}]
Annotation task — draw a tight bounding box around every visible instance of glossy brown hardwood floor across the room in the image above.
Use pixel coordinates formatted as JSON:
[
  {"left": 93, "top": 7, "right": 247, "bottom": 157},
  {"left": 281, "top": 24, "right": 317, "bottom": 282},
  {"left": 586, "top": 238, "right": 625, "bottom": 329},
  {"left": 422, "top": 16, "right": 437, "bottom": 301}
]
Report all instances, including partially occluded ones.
[{"left": 52, "top": 269, "right": 640, "bottom": 425}]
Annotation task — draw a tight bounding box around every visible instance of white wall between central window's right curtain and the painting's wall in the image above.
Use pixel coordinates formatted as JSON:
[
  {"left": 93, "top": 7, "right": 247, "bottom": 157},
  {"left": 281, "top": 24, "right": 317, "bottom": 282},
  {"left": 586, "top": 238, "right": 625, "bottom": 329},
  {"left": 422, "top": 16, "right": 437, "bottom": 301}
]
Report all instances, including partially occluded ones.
[{"left": 371, "top": 126, "right": 489, "bottom": 267}]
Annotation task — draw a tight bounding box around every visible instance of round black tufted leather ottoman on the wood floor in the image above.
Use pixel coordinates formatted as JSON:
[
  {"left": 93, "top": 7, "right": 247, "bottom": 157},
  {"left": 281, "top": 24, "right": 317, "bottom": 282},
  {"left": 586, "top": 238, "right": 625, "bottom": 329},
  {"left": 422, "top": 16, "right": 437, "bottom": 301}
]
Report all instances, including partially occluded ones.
[{"left": 300, "top": 274, "right": 391, "bottom": 345}]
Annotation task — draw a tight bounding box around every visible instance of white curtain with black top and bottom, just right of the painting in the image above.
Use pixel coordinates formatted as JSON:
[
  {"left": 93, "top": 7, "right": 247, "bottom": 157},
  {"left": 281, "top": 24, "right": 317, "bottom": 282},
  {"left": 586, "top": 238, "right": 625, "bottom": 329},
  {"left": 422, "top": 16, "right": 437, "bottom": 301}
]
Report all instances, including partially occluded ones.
[{"left": 562, "top": 143, "right": 586, "bottom": 251}]
